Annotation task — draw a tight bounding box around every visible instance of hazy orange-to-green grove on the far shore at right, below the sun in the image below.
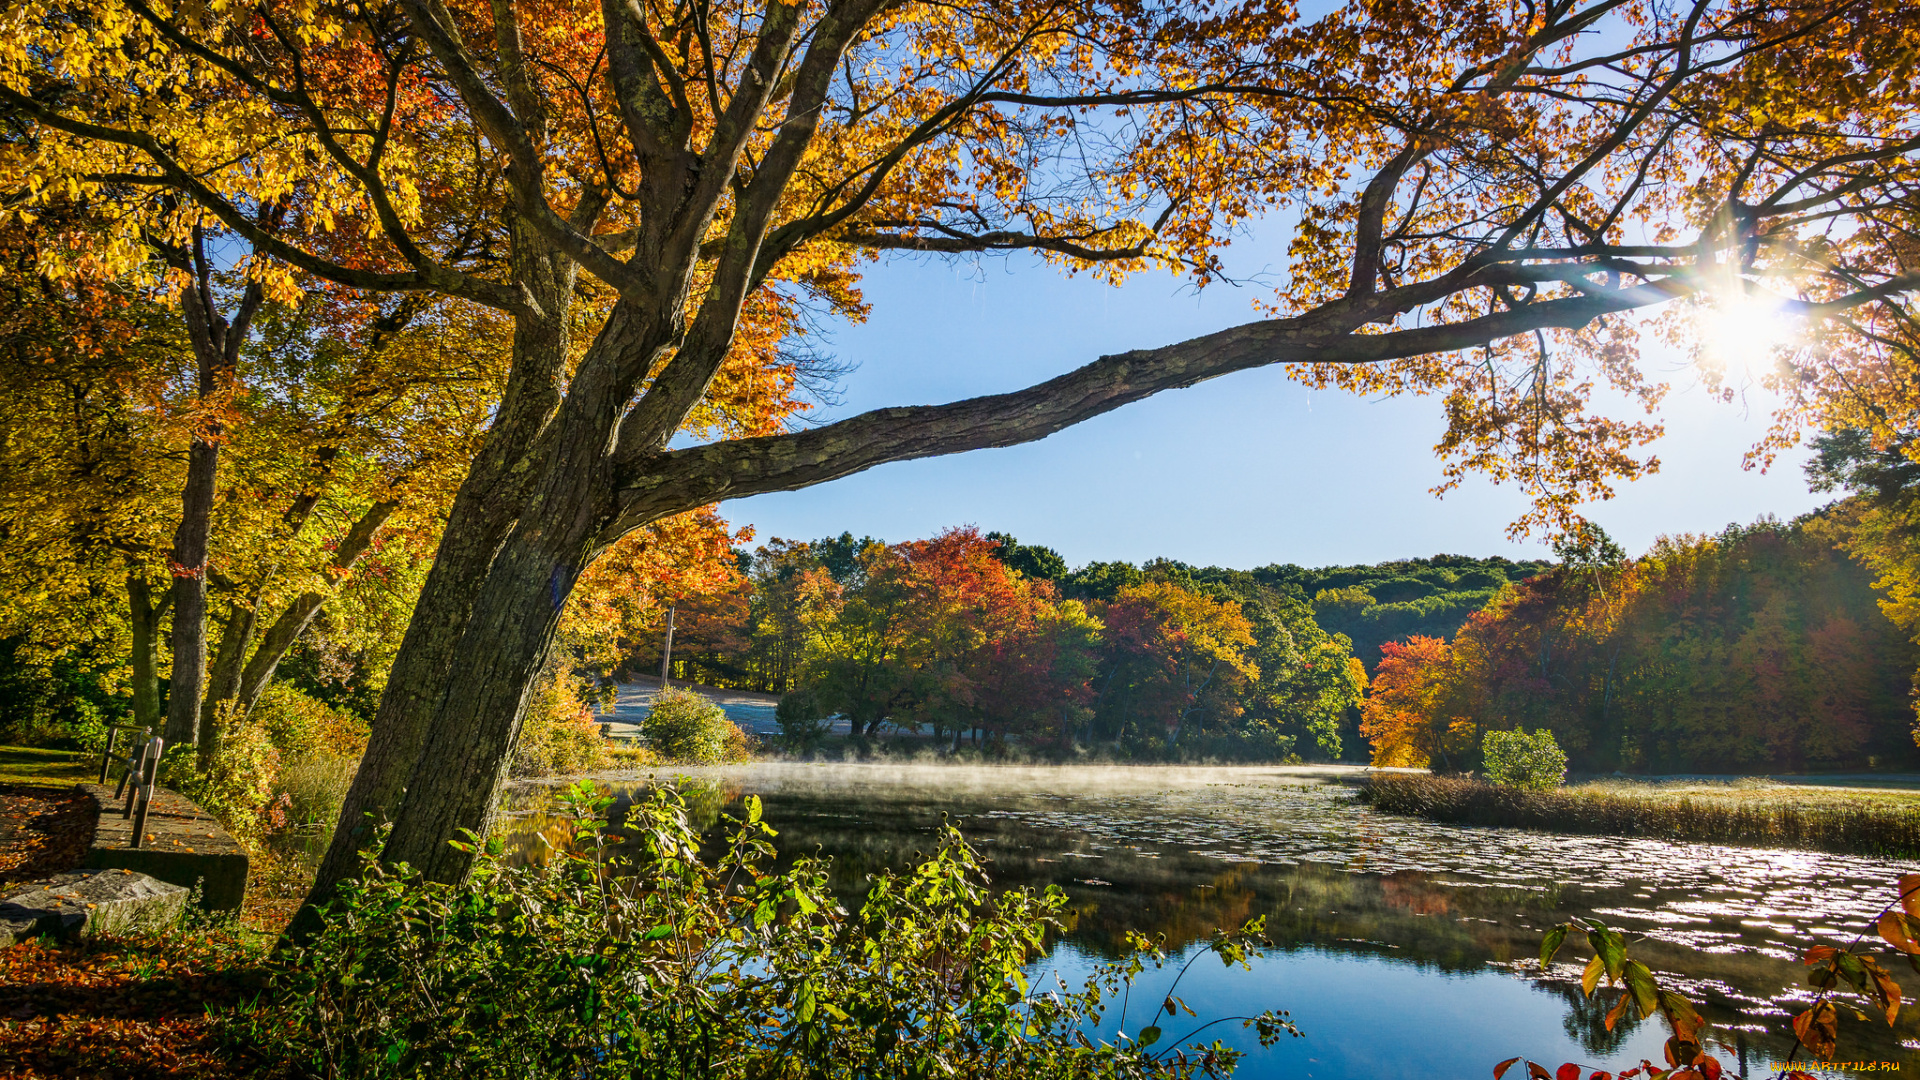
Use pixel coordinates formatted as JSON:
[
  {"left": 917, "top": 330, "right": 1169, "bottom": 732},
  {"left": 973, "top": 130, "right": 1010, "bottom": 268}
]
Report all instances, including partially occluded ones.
[{"left": 1363, "top": 503, "right": 1920, "bottom": 774}]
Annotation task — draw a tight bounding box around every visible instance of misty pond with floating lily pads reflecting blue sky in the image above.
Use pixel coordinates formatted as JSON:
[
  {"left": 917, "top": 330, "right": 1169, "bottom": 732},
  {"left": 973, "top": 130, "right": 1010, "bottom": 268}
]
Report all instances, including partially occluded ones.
[{"left": 509, "top": 763, "right": 1920, "bottom": 1080}]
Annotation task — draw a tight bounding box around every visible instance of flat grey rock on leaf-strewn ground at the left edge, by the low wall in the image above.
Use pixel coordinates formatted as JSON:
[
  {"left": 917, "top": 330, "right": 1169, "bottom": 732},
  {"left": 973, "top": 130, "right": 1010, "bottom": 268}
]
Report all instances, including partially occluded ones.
[{"left": 0, "top": 871, "right": 188, "bottom": 945}]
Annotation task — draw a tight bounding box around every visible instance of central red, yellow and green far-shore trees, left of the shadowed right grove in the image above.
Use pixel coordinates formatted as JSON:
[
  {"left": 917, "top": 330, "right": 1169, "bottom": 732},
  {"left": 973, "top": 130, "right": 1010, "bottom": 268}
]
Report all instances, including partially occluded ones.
[{"left": 652, "top": 528, "right": 1551, "bottom": 761}]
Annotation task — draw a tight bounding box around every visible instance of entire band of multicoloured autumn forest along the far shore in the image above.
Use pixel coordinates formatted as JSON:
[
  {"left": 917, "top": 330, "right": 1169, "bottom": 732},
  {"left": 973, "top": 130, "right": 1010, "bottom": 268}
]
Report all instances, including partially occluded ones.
[{"left": 637, "top": 509, "right": 1920, "bottom": 773}]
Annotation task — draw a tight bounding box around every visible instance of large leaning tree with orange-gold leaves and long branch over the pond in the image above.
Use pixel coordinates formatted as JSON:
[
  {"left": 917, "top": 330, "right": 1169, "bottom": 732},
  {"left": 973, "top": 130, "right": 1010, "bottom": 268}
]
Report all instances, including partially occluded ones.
[{"left": 0, "top": 0, "right": 1920, "bottom": 910}]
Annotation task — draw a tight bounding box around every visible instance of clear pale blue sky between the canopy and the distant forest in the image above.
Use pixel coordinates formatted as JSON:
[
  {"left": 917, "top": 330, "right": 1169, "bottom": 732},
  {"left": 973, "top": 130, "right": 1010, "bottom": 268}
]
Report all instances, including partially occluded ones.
[{"left": 722, "top": 245, "right": 1828, "bottom": 569}]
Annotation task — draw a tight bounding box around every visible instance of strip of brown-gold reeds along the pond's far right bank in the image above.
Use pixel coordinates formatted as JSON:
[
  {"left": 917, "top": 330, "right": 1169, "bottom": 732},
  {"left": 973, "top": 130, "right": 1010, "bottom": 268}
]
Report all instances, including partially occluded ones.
[{"left": 1361, "top": 773, "right": 1920, "bottom": 857}]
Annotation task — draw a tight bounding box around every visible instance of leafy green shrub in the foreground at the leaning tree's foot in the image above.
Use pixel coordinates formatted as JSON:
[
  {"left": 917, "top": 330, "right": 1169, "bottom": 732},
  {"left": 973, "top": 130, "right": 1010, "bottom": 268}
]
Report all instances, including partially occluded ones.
[{"left": 253, "top": 782, "right": 1298, "bottom": 1080}]
